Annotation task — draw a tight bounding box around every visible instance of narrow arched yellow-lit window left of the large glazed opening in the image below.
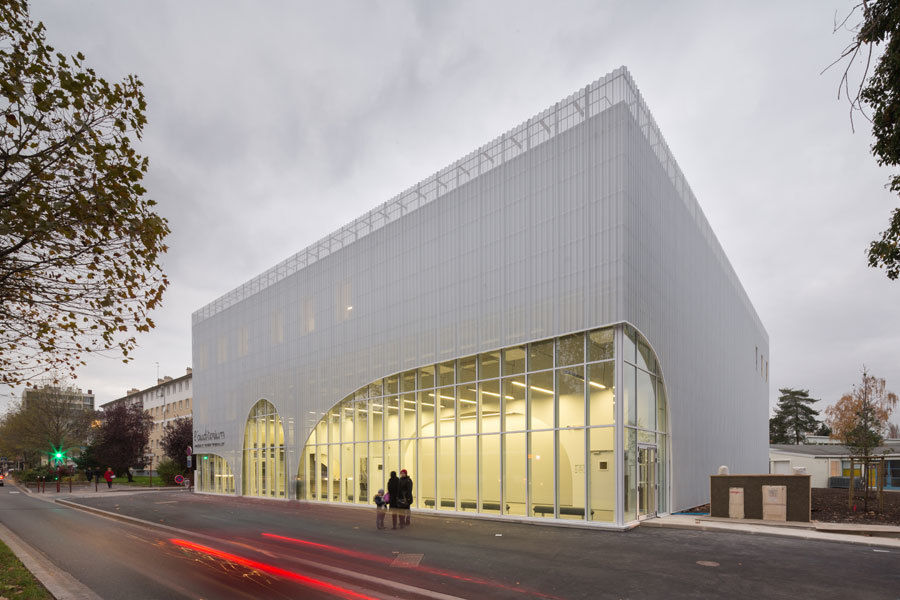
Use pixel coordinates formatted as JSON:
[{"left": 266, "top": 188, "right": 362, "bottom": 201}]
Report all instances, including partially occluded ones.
[{"left": 243, "top": 400, "right": 286, "bottom": 498}]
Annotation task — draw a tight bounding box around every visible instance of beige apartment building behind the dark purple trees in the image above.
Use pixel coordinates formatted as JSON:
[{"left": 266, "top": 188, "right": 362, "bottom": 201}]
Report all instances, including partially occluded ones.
[{"left": 102, "top": 367, "right": 193, "bottom": 471}]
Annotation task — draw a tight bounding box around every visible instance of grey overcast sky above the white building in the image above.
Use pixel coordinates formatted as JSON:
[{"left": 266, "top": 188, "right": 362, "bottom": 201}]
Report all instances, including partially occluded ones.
[{"left": 3, "top": 0, "right": 900, "bottom": 421}]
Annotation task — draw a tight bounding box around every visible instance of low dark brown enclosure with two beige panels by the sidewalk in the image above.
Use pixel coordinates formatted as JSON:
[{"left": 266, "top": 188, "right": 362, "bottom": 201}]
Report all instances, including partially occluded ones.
[{"left": 709, "top": 474, "right": 812, "bottom": 523}]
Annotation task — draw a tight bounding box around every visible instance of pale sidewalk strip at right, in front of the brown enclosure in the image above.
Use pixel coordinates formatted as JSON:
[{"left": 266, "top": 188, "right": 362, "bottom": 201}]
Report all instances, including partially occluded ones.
[{"left": 641, "top": 515, "right": 900, "bottom": 550}]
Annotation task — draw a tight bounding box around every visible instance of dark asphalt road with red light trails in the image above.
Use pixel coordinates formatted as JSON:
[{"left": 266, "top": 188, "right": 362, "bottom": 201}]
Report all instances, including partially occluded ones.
[{"left": 0, "top": 488, "right": 900, "bottom": 600}]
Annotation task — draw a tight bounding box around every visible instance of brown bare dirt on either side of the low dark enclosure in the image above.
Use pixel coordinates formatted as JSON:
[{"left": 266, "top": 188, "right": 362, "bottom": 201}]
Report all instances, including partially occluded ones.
[{"left": 685, "top": 488, "right": 900, "bottom": 525}]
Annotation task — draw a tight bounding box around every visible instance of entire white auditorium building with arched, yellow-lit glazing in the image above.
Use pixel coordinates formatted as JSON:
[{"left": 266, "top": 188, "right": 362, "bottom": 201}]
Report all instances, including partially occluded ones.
[{"left": 193, "top": 68, "right": 768, "bottom": 527}]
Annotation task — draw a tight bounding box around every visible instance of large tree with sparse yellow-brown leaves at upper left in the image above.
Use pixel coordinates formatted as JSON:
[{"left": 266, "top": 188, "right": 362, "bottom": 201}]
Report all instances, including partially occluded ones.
[{"left": 0, "top": 0, "right": 169, "bottom": 385}]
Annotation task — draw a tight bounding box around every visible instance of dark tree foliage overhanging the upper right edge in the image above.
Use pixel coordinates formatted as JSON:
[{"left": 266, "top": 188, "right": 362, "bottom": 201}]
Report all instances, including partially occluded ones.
[{"left": 832, "top": 0, "right": 900, "bottom": 279}]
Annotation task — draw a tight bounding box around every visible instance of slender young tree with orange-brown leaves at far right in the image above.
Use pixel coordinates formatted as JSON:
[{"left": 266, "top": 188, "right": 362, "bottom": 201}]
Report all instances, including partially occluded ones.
[{"left": 825, "top": 367, "right": 897, "bottom": 508}]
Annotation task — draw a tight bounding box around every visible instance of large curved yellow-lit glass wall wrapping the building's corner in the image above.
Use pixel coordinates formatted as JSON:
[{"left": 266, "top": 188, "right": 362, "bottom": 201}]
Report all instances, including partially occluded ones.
[{"left": 296, "top": 326, "right": 666, "bottom": 522}]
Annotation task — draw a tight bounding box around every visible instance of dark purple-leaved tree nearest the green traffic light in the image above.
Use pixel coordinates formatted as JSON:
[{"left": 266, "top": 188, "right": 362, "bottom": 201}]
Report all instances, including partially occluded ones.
[{"left": 92, "top": 403, "right": 153, "bottom": 481}]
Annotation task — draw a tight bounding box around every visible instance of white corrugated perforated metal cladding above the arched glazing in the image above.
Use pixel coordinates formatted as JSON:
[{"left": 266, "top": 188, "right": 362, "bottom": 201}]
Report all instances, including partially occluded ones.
[{"left": 193, "top": 69, "right": 768, "bottom": 508}]
